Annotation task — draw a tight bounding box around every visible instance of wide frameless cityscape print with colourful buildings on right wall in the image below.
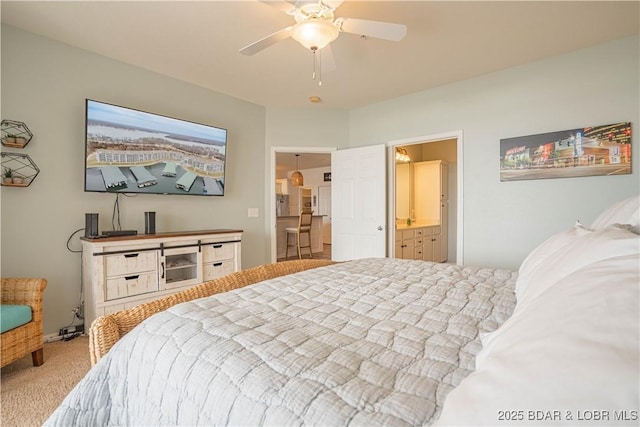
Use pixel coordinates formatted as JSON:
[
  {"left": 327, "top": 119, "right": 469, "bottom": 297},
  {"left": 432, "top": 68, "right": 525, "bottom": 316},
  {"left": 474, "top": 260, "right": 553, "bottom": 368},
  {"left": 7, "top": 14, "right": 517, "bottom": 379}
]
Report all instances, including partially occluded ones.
[{"left": 500, "top": 122, "right": 631, "bottom": 181}]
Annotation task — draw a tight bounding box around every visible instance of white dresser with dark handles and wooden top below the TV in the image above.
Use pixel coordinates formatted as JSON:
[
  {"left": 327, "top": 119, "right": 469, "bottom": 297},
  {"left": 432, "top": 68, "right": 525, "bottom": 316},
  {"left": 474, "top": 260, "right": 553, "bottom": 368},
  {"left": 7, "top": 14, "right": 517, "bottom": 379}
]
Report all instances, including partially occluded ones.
[{"left": 81, "top": 230, "right": 242, "bottom": 329}]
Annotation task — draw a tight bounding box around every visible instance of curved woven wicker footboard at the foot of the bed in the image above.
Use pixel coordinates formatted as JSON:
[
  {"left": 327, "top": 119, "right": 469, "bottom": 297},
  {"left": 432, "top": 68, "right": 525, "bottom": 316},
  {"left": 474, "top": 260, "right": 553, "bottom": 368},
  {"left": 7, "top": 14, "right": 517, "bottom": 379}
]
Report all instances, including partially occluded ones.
[{"left": 89, "top": 259, "right": 333, "bottom": 366}]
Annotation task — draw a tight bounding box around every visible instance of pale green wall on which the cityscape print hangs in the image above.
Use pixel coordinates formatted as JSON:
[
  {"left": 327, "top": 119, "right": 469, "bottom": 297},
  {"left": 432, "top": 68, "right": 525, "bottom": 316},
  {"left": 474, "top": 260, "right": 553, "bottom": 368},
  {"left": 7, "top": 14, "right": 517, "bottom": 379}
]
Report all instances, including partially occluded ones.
[{"left": 349, "top": 35, "right": 640, "bottom": 269}]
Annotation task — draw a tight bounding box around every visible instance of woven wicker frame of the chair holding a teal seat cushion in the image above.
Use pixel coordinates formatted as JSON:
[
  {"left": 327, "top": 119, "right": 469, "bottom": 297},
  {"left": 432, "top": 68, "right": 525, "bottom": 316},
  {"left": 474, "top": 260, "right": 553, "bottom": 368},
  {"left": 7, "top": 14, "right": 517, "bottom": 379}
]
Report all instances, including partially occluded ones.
[{"left": 0, "top": 278, "right": 47, "bottom": 366}]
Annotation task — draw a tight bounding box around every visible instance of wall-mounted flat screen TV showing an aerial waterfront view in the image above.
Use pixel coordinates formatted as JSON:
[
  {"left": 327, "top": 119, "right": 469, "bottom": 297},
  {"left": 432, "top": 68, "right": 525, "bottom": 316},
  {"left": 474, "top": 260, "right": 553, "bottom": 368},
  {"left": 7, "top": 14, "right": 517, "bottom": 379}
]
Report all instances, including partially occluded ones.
[{"left": 84, "top": 99, "right": 227, "bottom": 196}]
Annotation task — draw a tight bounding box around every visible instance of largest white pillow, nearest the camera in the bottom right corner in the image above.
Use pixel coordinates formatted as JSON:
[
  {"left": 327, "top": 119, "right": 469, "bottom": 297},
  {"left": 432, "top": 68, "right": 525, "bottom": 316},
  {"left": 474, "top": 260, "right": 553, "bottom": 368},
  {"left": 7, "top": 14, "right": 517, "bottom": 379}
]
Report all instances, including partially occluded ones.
[{"left": 435, "top": 253, "right": 640, "bottom": 426}]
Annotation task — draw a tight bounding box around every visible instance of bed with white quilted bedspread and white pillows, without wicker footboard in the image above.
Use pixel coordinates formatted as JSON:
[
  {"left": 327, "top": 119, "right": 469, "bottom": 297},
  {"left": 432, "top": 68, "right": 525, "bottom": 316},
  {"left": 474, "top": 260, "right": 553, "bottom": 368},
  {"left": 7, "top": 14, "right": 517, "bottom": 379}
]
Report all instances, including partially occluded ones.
[{"left": 45, "top": 197, "right": 640, "bottom": 426}]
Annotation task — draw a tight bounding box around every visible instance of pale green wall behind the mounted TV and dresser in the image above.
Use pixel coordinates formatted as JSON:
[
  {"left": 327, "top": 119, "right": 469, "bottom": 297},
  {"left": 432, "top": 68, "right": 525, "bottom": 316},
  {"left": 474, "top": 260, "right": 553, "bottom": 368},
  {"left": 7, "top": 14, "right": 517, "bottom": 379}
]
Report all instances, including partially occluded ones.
[{"left": 0, "top": 25, "right": 267, "bottom": 334}]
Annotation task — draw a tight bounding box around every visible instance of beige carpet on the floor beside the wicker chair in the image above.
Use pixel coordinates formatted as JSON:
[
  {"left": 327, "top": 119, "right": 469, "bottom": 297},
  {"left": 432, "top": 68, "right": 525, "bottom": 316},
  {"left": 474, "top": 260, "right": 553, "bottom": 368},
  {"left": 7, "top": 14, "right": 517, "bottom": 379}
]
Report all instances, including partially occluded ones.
[{"left": 0, "top": 336, "right": 91, "bottom": 427}]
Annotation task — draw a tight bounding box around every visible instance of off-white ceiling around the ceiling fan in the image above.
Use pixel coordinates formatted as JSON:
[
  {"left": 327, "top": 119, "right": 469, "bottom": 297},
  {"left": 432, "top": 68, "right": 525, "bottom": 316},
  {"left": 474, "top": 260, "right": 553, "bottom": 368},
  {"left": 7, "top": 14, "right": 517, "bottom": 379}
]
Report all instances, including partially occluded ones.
[{"left": 1, "top": 0, "right": 640, "bottom": 109}]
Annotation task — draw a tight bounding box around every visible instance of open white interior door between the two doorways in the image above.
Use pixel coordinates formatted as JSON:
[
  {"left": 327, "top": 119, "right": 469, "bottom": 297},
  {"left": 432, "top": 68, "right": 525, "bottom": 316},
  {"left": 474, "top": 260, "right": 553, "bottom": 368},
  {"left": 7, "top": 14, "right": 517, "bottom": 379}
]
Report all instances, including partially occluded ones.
[{"left": 331, "top": 145, "right": 386, "bottom": 261}]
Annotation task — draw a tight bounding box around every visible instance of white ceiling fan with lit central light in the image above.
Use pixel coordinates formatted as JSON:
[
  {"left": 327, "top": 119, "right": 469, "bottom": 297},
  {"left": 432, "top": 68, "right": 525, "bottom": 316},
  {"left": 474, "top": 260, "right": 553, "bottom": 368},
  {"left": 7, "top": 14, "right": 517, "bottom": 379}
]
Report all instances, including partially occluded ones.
[{"left": 240, "top": 0, "right": 407, "bottom": 55}]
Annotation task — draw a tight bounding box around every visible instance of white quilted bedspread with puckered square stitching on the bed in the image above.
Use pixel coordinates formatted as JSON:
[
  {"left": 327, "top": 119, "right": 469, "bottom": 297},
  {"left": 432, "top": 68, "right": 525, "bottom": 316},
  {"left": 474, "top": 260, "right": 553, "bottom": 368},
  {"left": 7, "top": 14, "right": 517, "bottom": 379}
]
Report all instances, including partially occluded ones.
[{"left": 47, "top": 259, "right": 515, "bottom": 426}]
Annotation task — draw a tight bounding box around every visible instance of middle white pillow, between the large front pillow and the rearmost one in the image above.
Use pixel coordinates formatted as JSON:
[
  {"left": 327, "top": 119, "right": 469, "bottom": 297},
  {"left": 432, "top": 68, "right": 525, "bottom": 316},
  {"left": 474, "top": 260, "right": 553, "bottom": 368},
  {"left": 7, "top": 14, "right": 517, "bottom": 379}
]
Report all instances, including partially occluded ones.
[{"left": 514, "top": 225, "right": 640, "bottom": 315}]
